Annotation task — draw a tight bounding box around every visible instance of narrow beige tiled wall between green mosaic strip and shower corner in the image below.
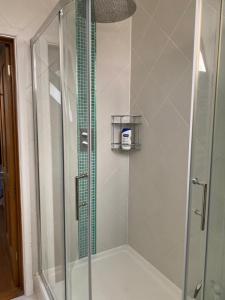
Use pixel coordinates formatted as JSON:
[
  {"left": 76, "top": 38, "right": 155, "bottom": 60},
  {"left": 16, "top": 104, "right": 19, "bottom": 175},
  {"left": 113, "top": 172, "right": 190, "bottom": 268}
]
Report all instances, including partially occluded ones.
[{"left": 96, "top": 19, "right": 131, "bottom": 252}]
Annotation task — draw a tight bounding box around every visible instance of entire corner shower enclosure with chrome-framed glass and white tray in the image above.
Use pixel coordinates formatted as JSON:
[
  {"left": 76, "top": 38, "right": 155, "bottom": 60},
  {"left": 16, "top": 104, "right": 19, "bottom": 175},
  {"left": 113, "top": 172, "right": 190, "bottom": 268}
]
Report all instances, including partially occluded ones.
[{"left": 31, "top": 0, "right": 225, "bottom": 300}]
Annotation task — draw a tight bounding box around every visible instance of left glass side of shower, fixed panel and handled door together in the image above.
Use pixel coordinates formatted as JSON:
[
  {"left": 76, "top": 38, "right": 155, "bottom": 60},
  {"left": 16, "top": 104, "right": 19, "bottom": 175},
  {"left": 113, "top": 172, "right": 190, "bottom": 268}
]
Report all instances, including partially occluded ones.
[{"left": 32, "top": 0, "right": 93, "bottom": 300}]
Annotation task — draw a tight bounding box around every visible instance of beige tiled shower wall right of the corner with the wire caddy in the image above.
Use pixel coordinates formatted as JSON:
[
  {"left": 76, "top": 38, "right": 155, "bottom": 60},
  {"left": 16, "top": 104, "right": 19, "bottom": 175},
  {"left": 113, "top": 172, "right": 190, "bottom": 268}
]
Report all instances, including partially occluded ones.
[{"left": 128, "top": 0, "right": 195, "bottom": 287}]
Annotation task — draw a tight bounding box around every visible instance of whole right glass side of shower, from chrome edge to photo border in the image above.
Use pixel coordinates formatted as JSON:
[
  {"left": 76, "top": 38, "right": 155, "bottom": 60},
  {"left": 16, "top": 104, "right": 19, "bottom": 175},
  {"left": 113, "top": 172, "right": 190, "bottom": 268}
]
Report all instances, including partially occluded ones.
[{"left": 184, "top": 1, "right": 225, "bottom": 300}]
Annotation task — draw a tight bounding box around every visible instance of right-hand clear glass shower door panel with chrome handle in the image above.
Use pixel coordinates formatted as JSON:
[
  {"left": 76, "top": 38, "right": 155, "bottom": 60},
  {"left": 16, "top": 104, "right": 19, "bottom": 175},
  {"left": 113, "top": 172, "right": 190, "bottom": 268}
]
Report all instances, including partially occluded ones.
[{"left": 186, "top": 0, "right": 220, "bottom": 299}]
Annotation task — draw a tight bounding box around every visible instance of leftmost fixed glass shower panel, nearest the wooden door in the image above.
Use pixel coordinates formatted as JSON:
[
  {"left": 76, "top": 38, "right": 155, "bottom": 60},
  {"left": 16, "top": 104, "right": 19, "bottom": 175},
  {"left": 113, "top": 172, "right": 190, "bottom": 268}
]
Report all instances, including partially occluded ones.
[{"left": 34, "top": 16, "right": 65, "bottom": 300}]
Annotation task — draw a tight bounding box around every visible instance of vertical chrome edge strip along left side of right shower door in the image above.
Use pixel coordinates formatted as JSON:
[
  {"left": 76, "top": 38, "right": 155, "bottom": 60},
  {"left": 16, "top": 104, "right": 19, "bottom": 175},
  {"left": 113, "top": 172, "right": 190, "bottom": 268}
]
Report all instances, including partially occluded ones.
[{"left": 182, "top": 0, "right": 203, "bottom": 300}]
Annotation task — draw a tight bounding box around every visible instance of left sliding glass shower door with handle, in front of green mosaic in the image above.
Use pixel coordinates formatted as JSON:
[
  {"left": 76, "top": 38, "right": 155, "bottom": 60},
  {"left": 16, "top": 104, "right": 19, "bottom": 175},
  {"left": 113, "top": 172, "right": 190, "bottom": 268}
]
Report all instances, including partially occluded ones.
[{"left": 61, "top": 1, "right": 89, "bottom": 300}]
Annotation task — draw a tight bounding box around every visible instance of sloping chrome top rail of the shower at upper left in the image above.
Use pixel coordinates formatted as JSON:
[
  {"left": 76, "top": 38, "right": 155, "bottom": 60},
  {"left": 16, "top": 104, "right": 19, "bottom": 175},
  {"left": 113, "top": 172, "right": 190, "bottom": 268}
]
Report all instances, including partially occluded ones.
[{"left": 31, "top": 0, "right": 74, "bottom": 45}]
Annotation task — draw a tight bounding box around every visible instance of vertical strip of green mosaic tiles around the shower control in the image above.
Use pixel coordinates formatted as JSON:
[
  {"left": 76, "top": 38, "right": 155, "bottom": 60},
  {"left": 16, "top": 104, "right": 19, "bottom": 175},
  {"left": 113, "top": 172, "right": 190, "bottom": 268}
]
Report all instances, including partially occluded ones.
[{"left": 75, "top": 0, "right": 96, "bottom": 258}]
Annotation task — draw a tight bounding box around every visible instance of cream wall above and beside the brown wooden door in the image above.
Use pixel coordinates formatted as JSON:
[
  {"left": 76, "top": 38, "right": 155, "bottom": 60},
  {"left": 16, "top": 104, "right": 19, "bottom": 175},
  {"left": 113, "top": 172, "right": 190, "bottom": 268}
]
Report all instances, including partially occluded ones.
[{"left": 0, "top": 0, "right": 57, "bottom": 295}]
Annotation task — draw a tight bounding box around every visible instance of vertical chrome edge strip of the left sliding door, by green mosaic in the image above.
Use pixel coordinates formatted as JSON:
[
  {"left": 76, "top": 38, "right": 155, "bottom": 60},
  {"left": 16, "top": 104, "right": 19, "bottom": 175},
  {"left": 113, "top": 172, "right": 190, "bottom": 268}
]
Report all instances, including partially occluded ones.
[{"left": 86, "top": 0, "right": 92, "bottom": 300}]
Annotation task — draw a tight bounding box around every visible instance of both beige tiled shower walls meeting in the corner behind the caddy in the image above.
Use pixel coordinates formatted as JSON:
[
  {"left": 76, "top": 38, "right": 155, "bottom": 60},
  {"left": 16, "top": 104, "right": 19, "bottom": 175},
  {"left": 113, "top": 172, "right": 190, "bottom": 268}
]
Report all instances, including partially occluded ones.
[{"left": 73, "top": 0, "right": 195, "bottom": 286}]
